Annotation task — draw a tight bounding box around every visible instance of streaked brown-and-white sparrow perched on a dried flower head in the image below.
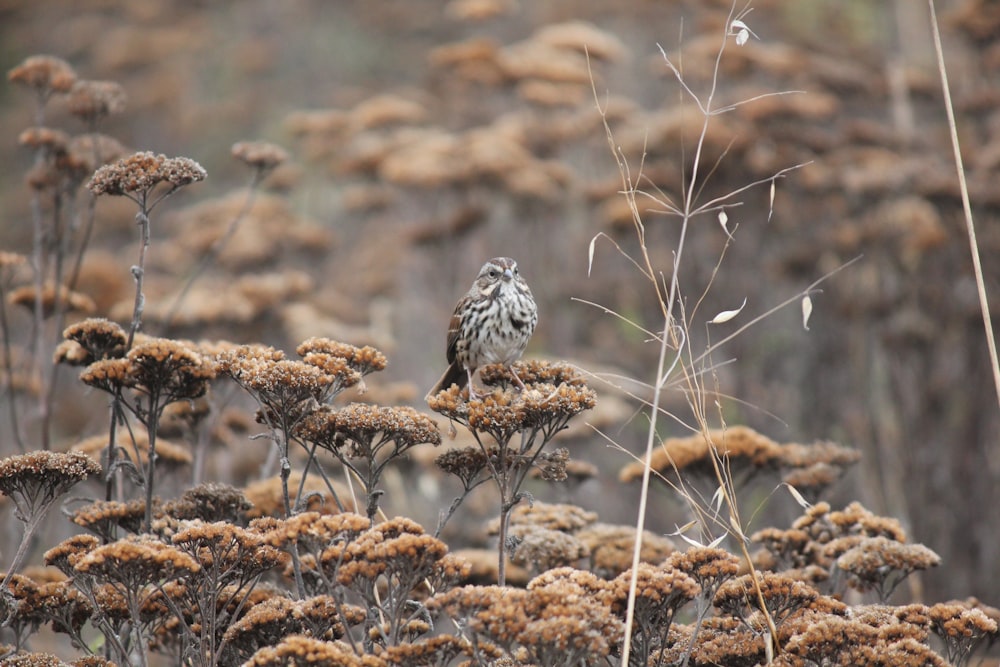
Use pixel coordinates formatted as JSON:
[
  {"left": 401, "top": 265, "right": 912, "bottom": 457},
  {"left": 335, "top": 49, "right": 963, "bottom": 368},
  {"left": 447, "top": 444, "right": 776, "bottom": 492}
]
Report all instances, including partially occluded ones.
[{"left": 431, "top": 257, "right": 538, "bottom": 400}]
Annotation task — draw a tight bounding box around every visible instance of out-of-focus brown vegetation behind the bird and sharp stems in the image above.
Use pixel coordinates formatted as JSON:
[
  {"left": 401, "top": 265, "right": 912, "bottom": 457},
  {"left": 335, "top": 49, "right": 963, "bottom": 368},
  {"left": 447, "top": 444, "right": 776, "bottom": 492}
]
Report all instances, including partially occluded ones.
[{"left": 0, "top": 0, "right": 1000, "bottom": 604}]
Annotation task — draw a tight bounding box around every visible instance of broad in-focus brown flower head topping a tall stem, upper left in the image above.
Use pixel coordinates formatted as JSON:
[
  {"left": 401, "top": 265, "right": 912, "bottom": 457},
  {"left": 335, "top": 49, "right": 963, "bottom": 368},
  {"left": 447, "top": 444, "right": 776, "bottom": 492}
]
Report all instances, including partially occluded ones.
[{"left": 87, "top": 151, "right": 207, "bottom": 199}]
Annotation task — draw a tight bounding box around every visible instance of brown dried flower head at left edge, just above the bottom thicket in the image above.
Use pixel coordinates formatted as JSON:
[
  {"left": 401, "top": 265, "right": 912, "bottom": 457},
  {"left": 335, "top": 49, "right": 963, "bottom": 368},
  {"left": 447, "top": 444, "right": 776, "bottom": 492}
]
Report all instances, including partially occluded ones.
[{"left": 0, "top": 451, "right": 101, "bottom": 522}]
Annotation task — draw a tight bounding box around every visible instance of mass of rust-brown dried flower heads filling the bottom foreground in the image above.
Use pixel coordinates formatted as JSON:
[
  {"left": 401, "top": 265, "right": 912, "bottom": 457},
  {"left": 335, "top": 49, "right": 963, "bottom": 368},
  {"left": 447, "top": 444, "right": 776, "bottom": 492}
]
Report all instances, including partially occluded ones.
[{"left": 0, "top": 444, "right": 1000, "bottom": 667}]
